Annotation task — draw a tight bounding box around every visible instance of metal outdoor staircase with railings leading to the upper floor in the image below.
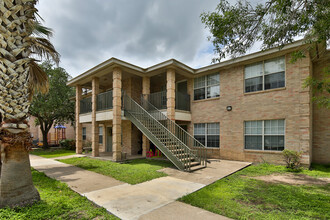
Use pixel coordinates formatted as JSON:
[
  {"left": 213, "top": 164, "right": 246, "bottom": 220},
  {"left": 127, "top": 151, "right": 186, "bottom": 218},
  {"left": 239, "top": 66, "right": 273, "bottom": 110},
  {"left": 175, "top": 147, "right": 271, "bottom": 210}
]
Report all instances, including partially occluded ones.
[{"left": 123, "top": 94, "right": 207, "bottom": 172}]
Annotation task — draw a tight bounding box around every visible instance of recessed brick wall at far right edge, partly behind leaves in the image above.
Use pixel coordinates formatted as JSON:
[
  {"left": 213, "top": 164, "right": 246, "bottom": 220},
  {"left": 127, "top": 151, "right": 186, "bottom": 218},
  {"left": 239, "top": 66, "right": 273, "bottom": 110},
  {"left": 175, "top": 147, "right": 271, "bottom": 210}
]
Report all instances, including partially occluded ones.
[{"left": 313, "top": 52, "right": 330, "bottom": 164}]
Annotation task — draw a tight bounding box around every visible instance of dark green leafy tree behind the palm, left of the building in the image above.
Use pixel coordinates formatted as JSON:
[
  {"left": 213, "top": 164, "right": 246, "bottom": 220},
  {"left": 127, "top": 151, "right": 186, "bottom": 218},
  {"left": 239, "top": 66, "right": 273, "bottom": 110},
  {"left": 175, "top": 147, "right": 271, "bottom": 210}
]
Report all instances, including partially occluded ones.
[{"left": 29, "top": 62, "right": 75, "bottom": 148}]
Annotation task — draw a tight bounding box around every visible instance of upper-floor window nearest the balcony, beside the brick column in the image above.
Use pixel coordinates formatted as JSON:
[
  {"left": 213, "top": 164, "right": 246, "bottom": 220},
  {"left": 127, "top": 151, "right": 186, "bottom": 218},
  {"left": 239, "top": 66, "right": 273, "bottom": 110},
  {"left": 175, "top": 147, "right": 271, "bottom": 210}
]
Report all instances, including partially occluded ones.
[{"left": 194, "top": 73, "right": 220, "bottom": 100}]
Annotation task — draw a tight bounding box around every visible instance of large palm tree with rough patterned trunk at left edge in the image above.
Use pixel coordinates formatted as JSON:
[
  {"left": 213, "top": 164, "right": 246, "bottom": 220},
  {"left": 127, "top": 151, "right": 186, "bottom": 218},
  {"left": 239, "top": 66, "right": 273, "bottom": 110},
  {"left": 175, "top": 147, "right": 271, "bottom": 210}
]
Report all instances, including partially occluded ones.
[{"left": 0, "top": 0, "right": 59, "bottom": 208}]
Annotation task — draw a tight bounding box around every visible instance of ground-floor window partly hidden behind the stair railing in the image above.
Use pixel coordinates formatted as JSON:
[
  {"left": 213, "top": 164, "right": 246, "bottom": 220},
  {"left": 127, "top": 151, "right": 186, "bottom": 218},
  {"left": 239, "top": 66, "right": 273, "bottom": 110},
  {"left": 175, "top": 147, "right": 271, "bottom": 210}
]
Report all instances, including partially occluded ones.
[{"left": 194, "top": 123, "right": 220, "bottom": 148}]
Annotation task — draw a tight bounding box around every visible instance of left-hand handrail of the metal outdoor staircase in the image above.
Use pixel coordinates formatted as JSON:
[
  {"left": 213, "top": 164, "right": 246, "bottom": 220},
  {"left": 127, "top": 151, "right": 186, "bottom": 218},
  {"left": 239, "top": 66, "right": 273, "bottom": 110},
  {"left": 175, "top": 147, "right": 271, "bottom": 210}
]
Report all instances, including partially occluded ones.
[{"left": 123, "top": 93, "right": 194, "bottom": 170}]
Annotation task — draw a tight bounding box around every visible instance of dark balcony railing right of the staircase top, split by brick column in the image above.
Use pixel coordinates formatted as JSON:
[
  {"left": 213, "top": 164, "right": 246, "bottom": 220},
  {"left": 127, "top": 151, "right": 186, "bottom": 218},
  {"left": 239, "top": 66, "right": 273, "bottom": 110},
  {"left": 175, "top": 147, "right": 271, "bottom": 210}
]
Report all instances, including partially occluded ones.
[{"left": 147, "top": 91, "right": 190, "bottom": 111}]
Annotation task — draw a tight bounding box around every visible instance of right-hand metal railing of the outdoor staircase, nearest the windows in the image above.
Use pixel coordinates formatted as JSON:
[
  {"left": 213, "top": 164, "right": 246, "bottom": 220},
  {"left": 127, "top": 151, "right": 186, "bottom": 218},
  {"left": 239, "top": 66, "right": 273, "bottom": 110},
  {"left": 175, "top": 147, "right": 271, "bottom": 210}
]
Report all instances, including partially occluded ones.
[{"left": 141, "top": 95, "right": 207, "bottom": 166}]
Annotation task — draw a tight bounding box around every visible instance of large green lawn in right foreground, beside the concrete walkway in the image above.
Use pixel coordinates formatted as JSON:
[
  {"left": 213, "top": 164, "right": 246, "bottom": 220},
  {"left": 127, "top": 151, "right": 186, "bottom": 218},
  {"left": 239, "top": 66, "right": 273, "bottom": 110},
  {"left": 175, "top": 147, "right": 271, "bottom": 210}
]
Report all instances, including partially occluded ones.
[{"left": 180, "top": 164, "right": 330, "bottom": 219}]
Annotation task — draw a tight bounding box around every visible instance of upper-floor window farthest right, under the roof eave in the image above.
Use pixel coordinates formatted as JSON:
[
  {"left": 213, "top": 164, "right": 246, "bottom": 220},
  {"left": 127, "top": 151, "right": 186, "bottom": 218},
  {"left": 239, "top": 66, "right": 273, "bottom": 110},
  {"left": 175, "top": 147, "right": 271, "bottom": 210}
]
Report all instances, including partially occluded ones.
[{"left": 244, "top": 57, "right": 285, "bottom": 92}]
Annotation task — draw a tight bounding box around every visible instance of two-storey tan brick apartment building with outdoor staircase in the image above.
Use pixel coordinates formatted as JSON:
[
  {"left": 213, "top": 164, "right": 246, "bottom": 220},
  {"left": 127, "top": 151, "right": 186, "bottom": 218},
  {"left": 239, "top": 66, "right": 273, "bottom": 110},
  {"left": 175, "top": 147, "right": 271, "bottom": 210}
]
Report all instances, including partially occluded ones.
[{"left": 68, "top": 41, "right": 330, "bottom": 170}]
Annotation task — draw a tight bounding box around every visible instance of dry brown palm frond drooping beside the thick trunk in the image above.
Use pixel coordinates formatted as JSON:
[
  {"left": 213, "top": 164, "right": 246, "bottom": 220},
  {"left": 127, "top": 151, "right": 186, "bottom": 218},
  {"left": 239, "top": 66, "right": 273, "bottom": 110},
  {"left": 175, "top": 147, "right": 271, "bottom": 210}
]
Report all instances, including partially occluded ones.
[{"left": 29, "top": 61, "right": 49, "bottom": 100}]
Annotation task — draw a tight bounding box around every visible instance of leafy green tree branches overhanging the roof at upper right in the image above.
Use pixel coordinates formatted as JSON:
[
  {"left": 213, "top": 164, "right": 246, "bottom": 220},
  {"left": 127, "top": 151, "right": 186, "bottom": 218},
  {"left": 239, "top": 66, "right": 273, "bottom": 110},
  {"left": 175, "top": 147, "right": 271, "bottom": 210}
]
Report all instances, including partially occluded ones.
[{"left": 201, "top": 0, "right": 330, "bottom": 106}]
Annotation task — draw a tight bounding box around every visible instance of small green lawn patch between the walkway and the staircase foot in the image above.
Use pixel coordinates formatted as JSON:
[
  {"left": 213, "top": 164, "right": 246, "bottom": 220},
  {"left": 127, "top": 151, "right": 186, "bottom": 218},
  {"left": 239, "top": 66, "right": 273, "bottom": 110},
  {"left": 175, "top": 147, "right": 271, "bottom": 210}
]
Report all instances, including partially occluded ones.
[{"left": 59, "top": 157, "right": 172, "bottom": 184}]
